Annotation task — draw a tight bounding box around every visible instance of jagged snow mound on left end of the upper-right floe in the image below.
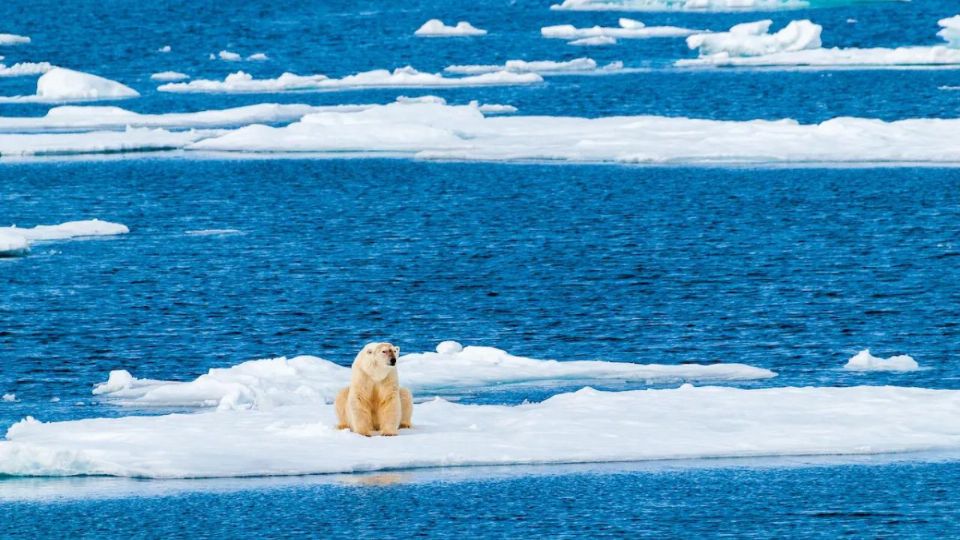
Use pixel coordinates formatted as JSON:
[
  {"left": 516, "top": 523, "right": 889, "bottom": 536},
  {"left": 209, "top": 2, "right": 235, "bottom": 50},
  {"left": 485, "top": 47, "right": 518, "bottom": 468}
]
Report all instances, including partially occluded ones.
[{"left": 687, "top": 20, "right": 823, "bottom": 56}]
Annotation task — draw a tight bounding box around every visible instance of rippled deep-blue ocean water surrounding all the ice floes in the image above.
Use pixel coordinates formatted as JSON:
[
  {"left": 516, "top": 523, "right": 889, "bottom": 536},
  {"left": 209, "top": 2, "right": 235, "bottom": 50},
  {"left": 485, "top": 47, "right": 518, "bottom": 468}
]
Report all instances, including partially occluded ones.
[{"left": 0, "top": 0, "right": 960, "bottom": 537}]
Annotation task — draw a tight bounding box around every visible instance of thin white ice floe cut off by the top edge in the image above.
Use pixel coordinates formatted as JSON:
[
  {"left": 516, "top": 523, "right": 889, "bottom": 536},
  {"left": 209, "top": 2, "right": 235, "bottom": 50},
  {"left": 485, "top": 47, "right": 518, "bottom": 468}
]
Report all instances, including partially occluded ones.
[{"left": 550, "top": 0, "right": 876, "bottom": 12}]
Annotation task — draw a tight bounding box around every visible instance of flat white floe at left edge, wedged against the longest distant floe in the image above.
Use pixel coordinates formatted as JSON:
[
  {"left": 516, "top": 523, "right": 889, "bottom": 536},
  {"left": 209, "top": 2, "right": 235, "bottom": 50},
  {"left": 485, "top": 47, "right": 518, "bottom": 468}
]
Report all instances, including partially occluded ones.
[{"left": 0, "top": 127, "right": 210, "bottom": 157}]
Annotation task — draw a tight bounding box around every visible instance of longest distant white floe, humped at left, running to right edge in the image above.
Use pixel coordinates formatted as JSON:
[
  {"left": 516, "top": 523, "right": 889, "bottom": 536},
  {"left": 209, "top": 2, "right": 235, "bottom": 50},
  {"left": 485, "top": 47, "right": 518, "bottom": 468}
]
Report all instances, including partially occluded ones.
[{"left": 189, "top": 97, "right": 960, "bottom": 164}]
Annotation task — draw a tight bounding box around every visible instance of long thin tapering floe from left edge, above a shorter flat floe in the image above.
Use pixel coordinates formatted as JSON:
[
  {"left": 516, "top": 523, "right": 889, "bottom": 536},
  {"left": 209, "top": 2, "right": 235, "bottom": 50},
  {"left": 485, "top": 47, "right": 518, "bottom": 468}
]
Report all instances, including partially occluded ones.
[{"left": 0, "top": 103, "right": 342, "bottom": 133}]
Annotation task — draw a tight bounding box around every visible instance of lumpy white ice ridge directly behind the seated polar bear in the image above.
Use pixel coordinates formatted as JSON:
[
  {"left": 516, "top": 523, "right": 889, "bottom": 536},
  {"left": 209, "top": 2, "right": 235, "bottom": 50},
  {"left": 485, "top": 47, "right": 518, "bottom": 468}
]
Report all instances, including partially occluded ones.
[{"left": 93, "top": 341, "right": 776, "bottom": 410}]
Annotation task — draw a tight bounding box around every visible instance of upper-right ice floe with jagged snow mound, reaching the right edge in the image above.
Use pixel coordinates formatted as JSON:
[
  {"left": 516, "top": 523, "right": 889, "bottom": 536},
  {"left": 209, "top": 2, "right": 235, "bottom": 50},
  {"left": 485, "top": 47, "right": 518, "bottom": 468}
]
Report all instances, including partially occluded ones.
[{"left": 675, "top": 16, "right": 960, "bottom": 68}]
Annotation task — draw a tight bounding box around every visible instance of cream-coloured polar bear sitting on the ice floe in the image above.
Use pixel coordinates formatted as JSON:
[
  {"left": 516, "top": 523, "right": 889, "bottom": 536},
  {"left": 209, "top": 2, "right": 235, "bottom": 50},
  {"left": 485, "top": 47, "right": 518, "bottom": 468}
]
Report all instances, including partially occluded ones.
[{"left": 334, "top": 343, "right": 413, "bottom": 437}]
